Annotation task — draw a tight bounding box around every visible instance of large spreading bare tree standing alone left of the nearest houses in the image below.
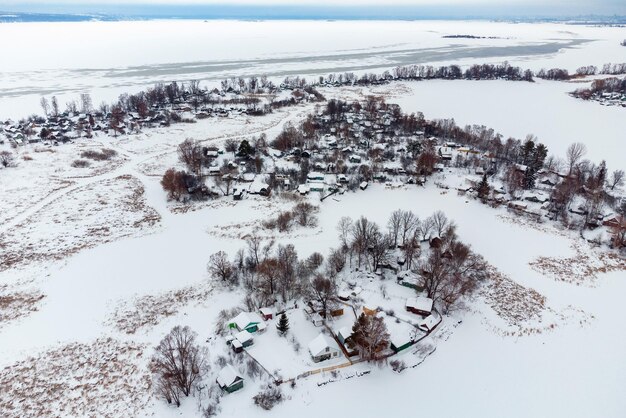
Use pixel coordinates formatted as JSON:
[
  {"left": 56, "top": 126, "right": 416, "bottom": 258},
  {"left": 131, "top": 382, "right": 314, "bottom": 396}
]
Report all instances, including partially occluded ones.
[{"left": 150, "top": 326, "right": 208, "bottom": 405}]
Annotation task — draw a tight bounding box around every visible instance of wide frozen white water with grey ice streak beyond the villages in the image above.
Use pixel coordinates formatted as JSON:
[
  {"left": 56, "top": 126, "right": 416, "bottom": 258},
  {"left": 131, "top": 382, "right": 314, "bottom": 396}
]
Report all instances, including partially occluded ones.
[{"left": 0, "top": 20, "right": 626, "bottom": 119}]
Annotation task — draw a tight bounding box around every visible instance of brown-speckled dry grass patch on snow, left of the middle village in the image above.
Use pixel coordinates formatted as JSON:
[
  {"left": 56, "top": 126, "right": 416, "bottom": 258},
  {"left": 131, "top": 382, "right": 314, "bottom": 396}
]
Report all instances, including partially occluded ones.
[{"left": 0, "top": 176, "right": 160, "bottom": 270}]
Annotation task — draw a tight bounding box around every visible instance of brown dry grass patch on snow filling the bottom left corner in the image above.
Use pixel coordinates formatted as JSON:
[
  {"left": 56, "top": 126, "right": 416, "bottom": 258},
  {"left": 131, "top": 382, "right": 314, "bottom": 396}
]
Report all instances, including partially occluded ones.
[{"left": 0, "top": 338, "right": 151, "bottom": 418}]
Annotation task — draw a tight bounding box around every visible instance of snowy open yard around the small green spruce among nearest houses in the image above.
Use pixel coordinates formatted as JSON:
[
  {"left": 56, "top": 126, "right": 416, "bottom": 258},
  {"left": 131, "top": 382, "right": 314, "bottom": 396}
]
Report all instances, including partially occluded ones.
[{"left": 247, "top": 309, "right": 348, "bottom": 379}]
